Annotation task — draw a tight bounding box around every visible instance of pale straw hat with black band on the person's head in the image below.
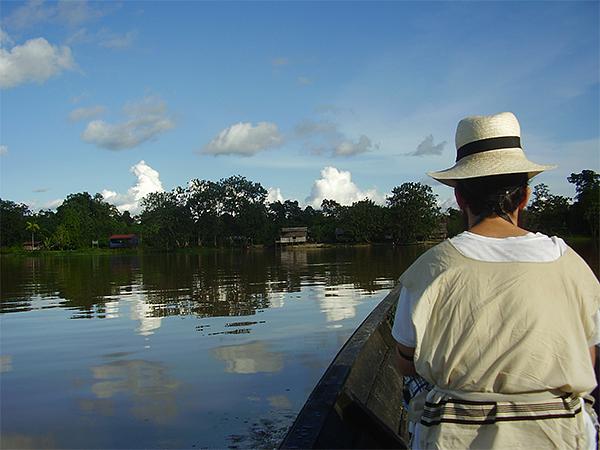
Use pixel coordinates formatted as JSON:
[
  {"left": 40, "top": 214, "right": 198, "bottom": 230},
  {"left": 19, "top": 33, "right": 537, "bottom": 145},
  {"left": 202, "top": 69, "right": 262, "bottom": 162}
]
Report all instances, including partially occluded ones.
[{"left": 428, "top": 112, "right": 556, "bottom": 186}]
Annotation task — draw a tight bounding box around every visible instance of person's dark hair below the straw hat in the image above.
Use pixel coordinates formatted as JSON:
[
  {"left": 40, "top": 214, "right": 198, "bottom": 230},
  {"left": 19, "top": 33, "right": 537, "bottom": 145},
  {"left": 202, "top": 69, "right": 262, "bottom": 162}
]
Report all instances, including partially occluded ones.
[{"left": 456, "top": 173, "right": 529, "bottom": 225}]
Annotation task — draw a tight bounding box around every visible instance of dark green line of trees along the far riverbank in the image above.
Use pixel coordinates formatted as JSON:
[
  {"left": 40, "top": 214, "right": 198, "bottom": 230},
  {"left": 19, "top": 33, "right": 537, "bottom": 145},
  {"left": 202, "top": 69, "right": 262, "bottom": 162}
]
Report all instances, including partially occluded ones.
[{"left": 0, "top": 170, "right": 600, "bottom": 250}]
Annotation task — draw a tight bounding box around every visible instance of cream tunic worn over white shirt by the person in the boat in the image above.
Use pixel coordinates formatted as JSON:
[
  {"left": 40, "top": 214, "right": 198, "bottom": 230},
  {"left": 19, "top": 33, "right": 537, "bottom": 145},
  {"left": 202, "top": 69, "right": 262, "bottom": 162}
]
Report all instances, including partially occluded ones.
[{"left": 400, "top": 241, "right": 600, "bottom": 449}]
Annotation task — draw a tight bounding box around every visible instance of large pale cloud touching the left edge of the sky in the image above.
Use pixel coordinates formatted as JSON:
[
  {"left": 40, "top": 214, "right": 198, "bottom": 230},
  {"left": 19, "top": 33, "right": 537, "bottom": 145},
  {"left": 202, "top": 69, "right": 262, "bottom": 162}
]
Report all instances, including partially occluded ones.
[{"left": 0, "top": 38, "right": 76, "bottom": 88}]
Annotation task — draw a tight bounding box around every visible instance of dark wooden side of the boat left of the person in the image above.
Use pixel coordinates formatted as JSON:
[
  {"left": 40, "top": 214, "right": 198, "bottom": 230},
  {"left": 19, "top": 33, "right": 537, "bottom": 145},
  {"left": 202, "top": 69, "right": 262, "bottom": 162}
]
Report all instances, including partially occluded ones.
[{"left": 281, "top": 289, "right": 407, "bottom": 448}]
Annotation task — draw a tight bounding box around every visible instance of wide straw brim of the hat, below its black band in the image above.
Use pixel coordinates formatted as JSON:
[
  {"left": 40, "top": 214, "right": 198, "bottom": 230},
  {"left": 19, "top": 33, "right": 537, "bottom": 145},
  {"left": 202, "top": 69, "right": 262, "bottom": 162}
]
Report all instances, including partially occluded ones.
[{"left": 427, "top": 148, "right": 557, "bottom": 187}]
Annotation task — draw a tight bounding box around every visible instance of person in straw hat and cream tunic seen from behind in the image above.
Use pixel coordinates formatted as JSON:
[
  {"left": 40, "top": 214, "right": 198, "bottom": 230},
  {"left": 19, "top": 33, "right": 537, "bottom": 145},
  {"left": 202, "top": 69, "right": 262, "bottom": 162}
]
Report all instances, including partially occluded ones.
[{"left": 392, "top": 112, "right": 600, "bottom": 449}]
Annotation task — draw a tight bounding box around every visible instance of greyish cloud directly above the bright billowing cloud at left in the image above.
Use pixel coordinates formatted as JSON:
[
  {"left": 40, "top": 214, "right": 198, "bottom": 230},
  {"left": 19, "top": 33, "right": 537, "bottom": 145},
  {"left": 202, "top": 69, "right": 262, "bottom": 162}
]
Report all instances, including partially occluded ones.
[{"left": 81, "top": 97, "right": 175, "bottom": 150}]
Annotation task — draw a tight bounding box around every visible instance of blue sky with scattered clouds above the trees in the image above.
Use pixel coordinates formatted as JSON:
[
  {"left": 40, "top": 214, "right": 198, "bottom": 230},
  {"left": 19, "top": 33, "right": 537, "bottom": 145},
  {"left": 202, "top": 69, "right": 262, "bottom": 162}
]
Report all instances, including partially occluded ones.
[{"left": 0, "top": 1, "right": 600, "bottom": 212}]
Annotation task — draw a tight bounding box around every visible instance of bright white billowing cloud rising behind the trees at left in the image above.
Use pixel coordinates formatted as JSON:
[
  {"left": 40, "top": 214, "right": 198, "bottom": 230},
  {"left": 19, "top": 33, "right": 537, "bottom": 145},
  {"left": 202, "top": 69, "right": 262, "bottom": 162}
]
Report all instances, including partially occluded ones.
[{"left": 102, "top": 160, "right": 164, "bottom": 214}]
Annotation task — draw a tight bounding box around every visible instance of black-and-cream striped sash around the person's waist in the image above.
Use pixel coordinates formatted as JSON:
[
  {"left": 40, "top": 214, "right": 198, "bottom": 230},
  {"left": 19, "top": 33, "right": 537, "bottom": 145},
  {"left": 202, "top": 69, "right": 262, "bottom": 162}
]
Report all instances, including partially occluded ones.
[{"left": 421, "top": 394, "right": 587, "bottom": 427}]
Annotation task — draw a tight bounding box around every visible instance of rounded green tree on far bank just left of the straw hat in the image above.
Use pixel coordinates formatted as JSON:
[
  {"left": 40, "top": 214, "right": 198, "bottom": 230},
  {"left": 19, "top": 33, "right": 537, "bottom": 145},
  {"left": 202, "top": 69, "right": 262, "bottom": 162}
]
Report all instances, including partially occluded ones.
[{"left": 386, "top": 183, "right": 440, "bottom": 243}]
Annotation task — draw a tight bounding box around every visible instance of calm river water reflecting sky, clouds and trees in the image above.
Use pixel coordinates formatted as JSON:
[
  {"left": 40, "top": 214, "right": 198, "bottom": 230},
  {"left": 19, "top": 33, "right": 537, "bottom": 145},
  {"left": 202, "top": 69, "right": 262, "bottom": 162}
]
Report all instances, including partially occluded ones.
[{"left": 0, "top": 246, "right": 598, "bottom": 449}]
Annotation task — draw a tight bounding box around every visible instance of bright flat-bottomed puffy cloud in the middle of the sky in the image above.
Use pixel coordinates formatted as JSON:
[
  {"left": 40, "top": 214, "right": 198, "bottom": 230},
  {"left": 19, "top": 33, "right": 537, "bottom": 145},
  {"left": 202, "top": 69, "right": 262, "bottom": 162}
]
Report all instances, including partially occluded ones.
[{"left": 203, "top": 122, "right": 283, "bottom": 156}]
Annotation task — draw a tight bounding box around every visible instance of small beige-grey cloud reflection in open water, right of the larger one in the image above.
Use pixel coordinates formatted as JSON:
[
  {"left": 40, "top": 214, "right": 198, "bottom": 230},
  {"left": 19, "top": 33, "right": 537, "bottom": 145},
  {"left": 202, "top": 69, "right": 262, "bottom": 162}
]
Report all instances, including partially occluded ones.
[{"left": 213, "top": 341, "right": 283, "bottom": 374}]
